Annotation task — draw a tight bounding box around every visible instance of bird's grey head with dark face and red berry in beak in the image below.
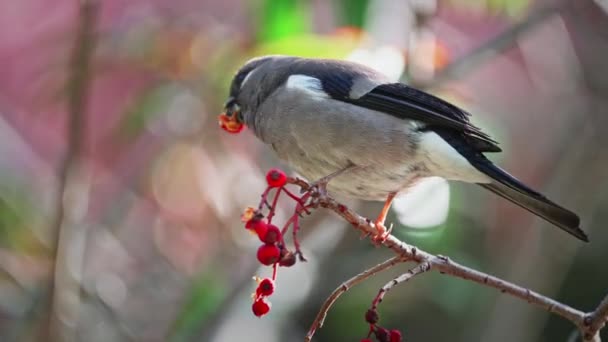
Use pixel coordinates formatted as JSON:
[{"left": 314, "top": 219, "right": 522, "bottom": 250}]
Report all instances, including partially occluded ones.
[{"left": 219, "top": 56, "right": 286, "bottom": 133}]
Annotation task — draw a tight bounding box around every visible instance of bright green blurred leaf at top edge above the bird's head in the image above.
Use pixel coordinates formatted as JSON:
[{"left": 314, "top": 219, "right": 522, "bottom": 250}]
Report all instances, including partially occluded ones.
[{"left": 259, "top": 0, "right": 310, "bottom": 41}]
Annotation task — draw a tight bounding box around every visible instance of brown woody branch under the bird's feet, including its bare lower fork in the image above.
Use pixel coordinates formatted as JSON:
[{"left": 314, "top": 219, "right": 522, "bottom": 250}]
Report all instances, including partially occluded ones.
[{"left": 289, "top": 178, "right": 608, "bottom": 342}]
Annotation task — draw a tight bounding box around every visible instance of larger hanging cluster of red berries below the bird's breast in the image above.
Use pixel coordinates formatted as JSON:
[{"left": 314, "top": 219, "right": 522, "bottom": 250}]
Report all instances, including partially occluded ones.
[{"left": 241, "top": 169, "right": 310, "bottom": 317}]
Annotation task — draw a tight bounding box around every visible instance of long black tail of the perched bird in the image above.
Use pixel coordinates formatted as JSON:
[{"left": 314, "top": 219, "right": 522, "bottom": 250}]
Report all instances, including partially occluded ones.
[{"left": 473, "top": 162, "right": 589, "bottom": 242}]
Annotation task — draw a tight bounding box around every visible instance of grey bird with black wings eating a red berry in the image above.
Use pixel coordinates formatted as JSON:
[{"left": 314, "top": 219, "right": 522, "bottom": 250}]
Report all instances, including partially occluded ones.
[{"left": 220, "top": 55, "right": 589, "bottom": 242}]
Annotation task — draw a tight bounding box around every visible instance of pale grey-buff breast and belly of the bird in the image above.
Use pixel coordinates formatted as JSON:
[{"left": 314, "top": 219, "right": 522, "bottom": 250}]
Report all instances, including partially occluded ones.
[{"left": 253, "top": 83, "right": 428, "bottom": 200}]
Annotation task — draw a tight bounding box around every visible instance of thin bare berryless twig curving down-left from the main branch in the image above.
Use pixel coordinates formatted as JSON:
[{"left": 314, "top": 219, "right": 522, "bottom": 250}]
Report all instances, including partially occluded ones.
[{"left": 304, "top": 256, "right": 407, "bottom": 342}]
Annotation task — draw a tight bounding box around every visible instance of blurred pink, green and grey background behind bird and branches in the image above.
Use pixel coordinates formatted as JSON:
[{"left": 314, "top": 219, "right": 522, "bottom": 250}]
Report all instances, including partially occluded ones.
[{"left": 0, "top": 0, "right": 608, "bottom": 342}]
